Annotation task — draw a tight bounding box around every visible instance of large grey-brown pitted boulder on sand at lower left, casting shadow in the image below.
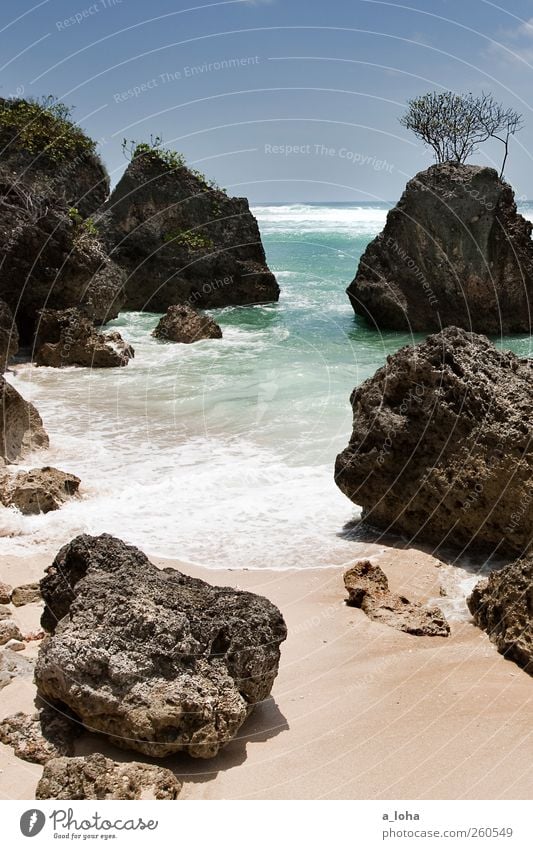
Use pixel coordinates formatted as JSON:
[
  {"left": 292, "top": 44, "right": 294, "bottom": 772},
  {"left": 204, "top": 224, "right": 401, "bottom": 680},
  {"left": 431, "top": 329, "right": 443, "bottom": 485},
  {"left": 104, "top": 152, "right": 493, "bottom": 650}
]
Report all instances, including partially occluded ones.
[{"left": 35, "top": 534, "right": 286, "bottom": 758}]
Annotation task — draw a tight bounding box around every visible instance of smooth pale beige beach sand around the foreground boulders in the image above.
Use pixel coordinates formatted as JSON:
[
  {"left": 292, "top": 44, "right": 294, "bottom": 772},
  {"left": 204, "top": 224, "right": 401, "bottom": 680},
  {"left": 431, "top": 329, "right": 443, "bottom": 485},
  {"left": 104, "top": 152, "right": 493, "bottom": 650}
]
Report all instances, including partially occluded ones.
[{"left": 0, "top": 546, "right": 533, "bottom": 799}]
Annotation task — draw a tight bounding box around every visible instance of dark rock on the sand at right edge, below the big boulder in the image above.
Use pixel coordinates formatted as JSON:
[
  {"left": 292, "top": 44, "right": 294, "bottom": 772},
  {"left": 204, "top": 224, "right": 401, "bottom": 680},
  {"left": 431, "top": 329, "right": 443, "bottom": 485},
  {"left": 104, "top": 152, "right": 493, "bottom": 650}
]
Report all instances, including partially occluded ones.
[{"left": 467, "top": 555, "right": 533, "bottom": 675}]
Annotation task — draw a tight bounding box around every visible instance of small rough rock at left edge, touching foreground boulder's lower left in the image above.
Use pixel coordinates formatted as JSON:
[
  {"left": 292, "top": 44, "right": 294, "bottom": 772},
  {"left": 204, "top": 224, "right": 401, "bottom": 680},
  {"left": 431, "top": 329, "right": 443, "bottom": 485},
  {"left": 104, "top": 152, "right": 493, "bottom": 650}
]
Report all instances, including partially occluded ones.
[{"left": 0, "top": 707, "right": 81, "bottom": 764}]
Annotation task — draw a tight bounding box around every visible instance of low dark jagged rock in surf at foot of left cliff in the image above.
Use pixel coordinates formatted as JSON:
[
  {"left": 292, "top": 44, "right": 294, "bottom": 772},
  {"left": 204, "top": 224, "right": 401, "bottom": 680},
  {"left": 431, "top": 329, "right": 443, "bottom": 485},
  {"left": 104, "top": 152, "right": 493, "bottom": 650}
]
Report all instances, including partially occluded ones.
[{"left": 35, "top": 308, "right": 135, "bottom": 368}]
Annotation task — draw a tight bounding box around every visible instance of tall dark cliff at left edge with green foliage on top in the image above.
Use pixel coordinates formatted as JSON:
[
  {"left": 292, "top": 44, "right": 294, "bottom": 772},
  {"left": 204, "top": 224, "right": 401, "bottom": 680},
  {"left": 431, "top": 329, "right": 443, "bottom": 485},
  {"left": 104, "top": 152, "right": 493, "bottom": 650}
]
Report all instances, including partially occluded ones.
[{"left": 0, "top": 98, "right": 125, "bottom": 344}]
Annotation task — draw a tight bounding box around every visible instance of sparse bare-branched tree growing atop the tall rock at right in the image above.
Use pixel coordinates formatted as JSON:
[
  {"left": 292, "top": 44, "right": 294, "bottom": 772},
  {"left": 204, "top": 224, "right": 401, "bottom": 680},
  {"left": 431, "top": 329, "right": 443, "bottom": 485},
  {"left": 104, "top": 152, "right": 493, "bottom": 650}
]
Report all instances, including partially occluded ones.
[{"left": 400, "top": 91, "right": 523, "bottom": 177}]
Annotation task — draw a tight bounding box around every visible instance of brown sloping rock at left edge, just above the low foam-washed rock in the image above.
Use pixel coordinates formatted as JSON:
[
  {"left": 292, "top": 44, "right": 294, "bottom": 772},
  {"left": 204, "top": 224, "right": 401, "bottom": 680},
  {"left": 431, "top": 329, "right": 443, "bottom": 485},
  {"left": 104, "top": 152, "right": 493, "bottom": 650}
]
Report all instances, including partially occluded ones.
[{"left": 0, "top": 376, "right": 48, "bottom": 463}]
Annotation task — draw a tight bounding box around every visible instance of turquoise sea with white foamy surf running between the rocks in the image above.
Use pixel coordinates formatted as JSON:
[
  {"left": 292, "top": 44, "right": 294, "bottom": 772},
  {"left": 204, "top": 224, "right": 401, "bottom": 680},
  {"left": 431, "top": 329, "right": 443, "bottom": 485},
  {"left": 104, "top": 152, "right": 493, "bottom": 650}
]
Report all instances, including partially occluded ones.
[{"left": 0, "top": 203, "right": 533, "bottom": 580}]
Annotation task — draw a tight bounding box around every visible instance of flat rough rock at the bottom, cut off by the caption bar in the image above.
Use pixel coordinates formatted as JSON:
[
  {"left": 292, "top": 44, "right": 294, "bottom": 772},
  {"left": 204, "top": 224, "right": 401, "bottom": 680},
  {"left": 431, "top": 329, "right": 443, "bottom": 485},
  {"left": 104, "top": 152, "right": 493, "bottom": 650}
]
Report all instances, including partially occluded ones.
[{"left": 35, "top": 754, "right": 181, "bottom": 799}]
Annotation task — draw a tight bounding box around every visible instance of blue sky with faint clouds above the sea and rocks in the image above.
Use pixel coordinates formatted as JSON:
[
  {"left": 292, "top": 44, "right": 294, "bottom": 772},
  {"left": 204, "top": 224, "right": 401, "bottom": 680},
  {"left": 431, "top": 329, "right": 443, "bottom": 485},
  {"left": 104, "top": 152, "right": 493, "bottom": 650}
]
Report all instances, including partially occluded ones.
[{"left": 0, "top": 0, "right": 533, "bottom": 204}]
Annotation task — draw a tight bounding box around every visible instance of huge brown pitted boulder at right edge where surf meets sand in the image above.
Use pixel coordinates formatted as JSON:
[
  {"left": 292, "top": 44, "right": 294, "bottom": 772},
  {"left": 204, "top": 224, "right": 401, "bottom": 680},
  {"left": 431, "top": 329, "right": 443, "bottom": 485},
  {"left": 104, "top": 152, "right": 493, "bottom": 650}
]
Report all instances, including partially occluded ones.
[{"left": 335, "top": 327, "right": 533, "bottom": 553}]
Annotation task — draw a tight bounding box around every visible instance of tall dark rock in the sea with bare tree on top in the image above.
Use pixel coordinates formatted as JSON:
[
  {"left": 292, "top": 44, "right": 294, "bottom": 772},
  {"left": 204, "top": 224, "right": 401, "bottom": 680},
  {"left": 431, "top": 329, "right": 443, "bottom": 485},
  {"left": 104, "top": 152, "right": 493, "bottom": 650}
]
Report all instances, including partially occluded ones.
[{"left": 347, "top": 162, "right": 533, "bottom": 334}]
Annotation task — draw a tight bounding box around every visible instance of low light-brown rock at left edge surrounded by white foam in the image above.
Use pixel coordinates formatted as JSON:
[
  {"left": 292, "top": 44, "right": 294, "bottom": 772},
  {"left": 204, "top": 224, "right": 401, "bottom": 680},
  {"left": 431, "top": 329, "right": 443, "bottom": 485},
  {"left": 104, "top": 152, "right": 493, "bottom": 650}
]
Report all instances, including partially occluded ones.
[{"left": 0, "top": 466, "right": 81, "bottom": 515}]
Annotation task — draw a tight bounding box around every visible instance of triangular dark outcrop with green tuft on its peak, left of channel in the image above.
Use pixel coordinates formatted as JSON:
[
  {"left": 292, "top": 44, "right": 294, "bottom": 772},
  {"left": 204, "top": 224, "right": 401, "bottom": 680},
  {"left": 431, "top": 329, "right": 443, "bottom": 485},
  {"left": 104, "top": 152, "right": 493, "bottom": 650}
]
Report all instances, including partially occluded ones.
[{"left": 102, "top": 149, "right": 279, "bottom": 312}]
